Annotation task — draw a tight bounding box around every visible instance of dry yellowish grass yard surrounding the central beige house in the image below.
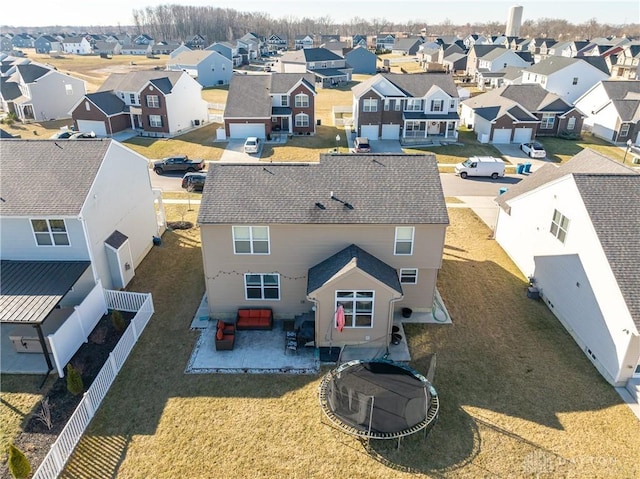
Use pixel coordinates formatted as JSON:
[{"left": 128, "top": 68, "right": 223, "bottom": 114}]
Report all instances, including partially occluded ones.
[{"left": 46, "top": 205, "right": 640, "bottom": 478}]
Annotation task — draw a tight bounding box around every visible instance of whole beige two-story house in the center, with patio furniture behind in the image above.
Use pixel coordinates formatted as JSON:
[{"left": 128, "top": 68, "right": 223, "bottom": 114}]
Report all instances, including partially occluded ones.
[{"left": 198, "top": 154, "right": 449, "bottom": 347}]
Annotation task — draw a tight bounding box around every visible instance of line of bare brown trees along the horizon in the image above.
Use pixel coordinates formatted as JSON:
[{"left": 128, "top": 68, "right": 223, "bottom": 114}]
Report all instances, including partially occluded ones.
[{"left": 133, "top": 5, "right": 640, "bottom": 43}]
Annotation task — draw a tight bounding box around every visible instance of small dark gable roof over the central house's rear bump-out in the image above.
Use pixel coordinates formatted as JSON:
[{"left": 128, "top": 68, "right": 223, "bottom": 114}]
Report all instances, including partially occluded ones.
[{"left": 307, "top": 244, "right": 402, "bottom": 294}]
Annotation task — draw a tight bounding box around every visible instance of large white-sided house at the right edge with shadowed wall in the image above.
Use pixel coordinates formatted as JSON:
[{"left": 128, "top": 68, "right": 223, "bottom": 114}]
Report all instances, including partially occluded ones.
[{"left": 495, "top": 149, "right": 640, "bottom": 386}]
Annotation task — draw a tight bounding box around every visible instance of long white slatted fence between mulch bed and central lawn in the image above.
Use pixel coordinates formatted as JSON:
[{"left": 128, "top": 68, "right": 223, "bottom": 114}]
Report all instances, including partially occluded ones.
[{"left": 33, "top": 290, "right": 153, "bottom": 479}]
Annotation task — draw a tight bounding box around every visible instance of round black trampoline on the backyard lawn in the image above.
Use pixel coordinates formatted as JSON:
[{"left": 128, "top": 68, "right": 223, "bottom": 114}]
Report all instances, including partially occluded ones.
[{"left": 319, "top": 360, "right": 440, "bottom": 447}]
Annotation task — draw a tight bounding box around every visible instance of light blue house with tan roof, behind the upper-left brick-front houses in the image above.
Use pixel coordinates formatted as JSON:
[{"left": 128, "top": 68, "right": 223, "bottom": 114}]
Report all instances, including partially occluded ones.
[{"left": 167, "top": 50, "right": 233, "bottom": 87}]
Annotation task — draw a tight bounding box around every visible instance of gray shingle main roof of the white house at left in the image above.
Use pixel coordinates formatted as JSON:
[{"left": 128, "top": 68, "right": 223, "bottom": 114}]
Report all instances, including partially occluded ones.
[{"left": 0, "top": 139, "right": 112, "bottom": 216}]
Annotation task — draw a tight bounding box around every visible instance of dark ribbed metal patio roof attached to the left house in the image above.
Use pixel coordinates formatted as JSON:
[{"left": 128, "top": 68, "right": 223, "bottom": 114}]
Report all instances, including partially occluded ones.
[{"left": 0, "top": 260, "right": 91, "bottom": 324}]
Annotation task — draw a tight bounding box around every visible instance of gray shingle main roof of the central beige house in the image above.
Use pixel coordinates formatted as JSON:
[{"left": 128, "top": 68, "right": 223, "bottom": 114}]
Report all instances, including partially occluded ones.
[{"left": 198, "top": 154, "right": 449, "bottom": 224}]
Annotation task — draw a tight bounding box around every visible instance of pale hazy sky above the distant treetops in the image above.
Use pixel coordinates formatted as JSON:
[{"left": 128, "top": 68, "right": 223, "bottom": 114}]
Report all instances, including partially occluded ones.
[{"left": 0, "top": 0, "right": 640, "bottom": 27}]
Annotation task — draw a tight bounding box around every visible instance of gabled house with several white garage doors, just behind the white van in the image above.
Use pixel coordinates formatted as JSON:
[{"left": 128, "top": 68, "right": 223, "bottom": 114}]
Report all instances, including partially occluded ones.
[{"left": 460, "top": 84, "right": 584, "bottom": 144}]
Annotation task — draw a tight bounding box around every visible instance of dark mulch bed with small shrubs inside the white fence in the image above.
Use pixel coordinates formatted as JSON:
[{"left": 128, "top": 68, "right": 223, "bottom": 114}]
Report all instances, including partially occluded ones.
[{"left": 0, "top": 312, "right": 135, "bottom": 477}]
